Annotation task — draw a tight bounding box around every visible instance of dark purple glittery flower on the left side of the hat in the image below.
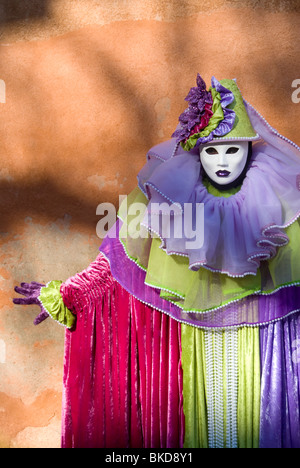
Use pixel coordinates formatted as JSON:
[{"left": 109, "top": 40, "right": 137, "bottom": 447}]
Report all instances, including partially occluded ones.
[{"left": 172, "top": 73, "right": 213, "bottom": 141}]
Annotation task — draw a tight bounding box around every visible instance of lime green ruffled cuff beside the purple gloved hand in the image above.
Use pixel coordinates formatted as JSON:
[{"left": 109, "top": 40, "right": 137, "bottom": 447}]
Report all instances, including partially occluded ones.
[{"left": 39, "top": 281, "right": 76, "bottom": 328}]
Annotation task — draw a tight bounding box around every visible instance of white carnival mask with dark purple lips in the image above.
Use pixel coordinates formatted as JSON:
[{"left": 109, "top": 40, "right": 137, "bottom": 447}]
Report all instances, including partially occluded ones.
[{"left": 200, "top": 141, "right": 248, "bottom": 185}]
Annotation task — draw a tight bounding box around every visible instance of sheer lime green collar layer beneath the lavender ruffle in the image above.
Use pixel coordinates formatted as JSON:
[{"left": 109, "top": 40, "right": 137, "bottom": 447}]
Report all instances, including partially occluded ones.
[{"left": 119, "top": 185, "right": 300, "bottom": 312}]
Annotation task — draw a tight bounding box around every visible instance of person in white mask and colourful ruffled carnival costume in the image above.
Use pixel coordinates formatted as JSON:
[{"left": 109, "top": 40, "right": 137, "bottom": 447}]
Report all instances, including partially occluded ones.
[{"left": 14, "top": 75, "right": 300, "bottom": 448}]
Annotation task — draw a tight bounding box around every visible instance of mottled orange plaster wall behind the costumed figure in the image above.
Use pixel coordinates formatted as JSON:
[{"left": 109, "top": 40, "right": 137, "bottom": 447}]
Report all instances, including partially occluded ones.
[{"left": 0, "top": 0, "right": 300, "bottom": 448}]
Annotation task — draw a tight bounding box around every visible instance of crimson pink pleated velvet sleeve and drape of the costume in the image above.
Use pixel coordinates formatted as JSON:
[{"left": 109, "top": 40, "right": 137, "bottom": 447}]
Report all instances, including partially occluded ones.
[{"left": 61, "top": 255, "right": 184, "bottom": 448}]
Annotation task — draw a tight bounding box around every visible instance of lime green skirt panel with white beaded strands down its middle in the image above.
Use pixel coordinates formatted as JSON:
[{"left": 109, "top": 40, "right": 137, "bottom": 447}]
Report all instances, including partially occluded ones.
[{"left": 181, "top": 324, "right": 260, "bottom": 448}]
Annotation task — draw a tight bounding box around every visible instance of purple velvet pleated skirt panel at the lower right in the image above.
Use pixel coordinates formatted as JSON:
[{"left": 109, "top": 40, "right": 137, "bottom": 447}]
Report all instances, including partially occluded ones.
[{"left": 260, "top": 314, "right": 300, "bottom": 448}]
